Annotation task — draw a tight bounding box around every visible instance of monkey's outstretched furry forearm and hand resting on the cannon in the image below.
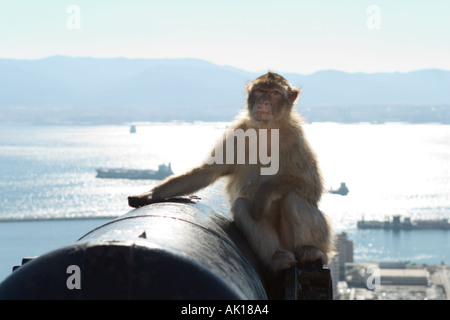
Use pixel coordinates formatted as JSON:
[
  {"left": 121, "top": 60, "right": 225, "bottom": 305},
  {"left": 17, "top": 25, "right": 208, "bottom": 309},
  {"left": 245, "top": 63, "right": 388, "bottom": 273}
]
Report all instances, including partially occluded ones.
[{"left": 128, "top": 164, "right": 233, "bottom": 208}]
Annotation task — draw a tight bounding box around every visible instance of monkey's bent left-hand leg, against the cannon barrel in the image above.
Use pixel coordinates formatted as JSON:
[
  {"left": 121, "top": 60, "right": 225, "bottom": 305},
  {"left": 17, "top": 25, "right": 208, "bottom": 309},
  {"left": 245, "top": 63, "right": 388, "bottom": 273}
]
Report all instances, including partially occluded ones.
[{"left": 231, "top": 198, "right": 296, "bottom": 273}]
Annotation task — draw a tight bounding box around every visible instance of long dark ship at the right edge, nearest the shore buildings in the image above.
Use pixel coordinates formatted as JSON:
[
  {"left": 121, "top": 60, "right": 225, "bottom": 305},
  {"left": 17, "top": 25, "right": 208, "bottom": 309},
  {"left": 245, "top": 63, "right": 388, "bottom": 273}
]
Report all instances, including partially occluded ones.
[{"left": 357, "top": 215, "right": 450, "bottom": 230}]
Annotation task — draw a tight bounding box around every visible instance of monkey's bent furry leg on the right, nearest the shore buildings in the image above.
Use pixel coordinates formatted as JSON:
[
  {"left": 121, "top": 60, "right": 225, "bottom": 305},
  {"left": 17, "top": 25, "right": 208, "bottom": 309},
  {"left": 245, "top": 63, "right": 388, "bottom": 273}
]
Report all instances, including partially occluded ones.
[{"left": 280, "top": 193, "right": 333, "bottom": 264}]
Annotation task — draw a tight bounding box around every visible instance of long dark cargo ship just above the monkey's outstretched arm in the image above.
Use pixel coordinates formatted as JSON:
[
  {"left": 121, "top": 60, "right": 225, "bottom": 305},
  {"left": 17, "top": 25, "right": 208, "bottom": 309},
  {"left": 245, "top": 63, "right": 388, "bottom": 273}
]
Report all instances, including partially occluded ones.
[{"left": 96, "top": 163, "right": 173, "bottom": 180}]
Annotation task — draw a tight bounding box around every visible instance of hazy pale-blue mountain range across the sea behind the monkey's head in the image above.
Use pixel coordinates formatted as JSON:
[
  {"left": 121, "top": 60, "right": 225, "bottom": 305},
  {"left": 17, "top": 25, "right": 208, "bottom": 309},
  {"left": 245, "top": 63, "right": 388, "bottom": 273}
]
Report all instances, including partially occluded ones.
[{"left": 0, "top": 56, "right": 450, "bottom": 124}]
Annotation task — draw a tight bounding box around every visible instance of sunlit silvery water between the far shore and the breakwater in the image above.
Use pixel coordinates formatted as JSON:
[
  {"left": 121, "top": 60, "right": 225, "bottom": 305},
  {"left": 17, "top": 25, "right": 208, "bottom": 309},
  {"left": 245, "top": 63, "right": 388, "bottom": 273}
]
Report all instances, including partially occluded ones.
[{"left": 0, "top": 122, "right": 450, "bottom": 230}]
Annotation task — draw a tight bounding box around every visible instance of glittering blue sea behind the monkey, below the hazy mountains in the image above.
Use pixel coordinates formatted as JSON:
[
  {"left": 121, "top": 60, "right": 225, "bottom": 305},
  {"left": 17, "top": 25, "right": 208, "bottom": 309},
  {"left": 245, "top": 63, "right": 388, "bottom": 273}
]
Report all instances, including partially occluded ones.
[{"left": 0, "top": 122, "right": 450, "bottom": 281}]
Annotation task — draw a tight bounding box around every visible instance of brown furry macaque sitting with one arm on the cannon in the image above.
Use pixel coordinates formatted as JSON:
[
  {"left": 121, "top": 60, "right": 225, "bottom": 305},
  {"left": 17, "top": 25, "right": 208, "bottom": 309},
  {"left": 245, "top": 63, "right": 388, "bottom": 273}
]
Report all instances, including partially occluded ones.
[{"left": 128, "top": 72, "right": 333, "bottom": 274}]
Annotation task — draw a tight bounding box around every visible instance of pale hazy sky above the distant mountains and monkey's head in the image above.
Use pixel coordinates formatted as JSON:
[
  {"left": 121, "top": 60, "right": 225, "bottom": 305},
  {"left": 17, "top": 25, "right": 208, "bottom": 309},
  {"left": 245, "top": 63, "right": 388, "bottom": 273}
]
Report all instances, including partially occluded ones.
[{"left": 0, "top": 0, "right": 450, "bottom": 74}]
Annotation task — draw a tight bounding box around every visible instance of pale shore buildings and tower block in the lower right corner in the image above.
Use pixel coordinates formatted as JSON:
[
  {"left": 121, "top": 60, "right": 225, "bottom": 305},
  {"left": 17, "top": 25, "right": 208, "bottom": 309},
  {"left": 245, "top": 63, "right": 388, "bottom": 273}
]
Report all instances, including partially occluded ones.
[{"left": 329, "top": 233, "right": 450, "bottom": 300}]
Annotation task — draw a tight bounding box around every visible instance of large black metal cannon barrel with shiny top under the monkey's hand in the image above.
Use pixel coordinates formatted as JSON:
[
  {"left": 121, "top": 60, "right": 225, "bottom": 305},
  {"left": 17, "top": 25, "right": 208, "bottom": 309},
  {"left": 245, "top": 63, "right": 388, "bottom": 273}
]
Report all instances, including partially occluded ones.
[{"left": 0, "top": 200, "right": 267, "bottom": 299}]
